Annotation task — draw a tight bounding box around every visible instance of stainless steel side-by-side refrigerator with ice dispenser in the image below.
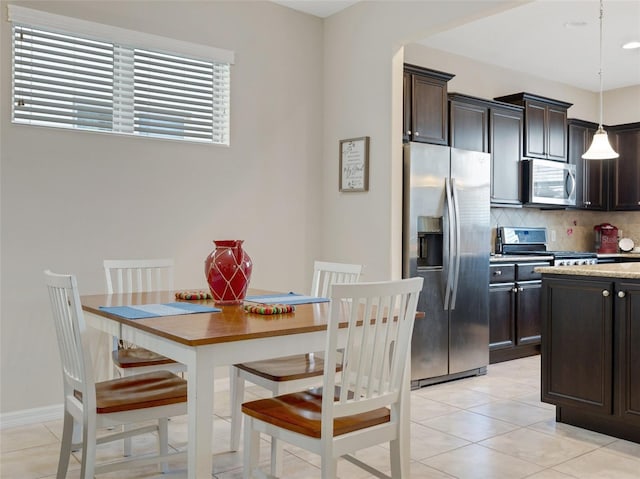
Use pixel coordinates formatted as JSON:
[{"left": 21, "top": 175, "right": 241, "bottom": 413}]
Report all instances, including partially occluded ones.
[{"left": 402, "top": 143, "right": 491, "bottom": 388}]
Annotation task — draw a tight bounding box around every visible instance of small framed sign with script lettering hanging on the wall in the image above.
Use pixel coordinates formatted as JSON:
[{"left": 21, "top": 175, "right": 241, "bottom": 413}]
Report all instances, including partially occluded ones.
[{"left": 340, "top": 136, "right": 369, "bottom": 191}]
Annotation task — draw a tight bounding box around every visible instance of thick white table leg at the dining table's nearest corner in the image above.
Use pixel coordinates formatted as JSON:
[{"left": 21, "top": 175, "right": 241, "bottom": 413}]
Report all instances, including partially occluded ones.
[{"left": 187, "top": 351, "right": 214, "bottom": 479}]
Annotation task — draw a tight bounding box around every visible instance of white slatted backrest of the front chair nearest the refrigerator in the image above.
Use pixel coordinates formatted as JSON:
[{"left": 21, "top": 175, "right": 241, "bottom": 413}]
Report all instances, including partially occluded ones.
[{"left": 322, "top": 278, "right": 423, "bottom": 434}]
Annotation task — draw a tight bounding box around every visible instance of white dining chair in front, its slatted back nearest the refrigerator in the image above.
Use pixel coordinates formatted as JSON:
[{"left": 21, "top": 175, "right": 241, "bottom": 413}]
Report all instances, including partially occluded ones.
[{"left": 242, "top": 278, "right": 423, "bottom": 479}]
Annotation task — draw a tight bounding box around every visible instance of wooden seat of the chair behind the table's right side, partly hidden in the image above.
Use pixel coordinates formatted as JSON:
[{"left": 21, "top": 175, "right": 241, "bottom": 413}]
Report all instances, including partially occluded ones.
[{"left": 235, "top": 354, "right": 342, "bottom": 382}]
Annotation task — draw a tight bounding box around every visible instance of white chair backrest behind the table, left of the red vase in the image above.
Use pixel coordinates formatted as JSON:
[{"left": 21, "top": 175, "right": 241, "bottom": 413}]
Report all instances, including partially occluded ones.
[{"left": 104, "top": 258, "right": 173, "bottom": 294}]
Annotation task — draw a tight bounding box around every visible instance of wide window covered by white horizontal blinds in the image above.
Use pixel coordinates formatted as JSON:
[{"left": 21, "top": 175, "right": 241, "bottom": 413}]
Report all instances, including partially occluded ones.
[{"left": 13, "top": 14, "right": 230, "bottom": 145}]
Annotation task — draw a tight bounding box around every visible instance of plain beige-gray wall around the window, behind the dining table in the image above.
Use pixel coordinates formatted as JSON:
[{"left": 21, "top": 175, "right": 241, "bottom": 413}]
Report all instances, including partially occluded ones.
[{"left": 0, "top": 1, "right": 323, "bottom": 412}]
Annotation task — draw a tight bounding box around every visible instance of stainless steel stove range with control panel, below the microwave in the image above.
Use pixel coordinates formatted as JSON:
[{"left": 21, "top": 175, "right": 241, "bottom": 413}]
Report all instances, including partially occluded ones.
[{"left": 500, "top": 226, "right": 598, "bottom": 266}]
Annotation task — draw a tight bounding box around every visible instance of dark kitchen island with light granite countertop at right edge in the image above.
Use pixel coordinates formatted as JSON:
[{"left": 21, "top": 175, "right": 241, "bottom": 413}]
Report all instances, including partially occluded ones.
[{"left": 536, "top": 263, "right": 640, "bottom": 442}]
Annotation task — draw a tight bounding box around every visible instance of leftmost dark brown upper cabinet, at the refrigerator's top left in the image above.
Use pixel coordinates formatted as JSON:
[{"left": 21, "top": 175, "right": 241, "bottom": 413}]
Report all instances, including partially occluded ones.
[{"left": 403, "top": 64, "right": 455, "bottom": 145}]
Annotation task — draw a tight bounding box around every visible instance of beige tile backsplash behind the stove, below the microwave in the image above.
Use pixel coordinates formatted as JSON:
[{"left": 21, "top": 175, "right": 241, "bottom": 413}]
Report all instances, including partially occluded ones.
[{"left": 491, "top": 208, "right": 640, "bottom": 255}]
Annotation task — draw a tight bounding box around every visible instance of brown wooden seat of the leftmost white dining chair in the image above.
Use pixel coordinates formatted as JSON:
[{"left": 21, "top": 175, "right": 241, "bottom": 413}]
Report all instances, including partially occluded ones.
[{"left": 74, "top": 371, "right": 187, "bottom": 414}]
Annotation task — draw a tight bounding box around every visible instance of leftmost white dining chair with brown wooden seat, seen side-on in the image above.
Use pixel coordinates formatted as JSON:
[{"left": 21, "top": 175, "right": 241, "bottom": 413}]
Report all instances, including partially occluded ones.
[{"left": 44, "top": 271, "right": 187, "bottom": 479}]
